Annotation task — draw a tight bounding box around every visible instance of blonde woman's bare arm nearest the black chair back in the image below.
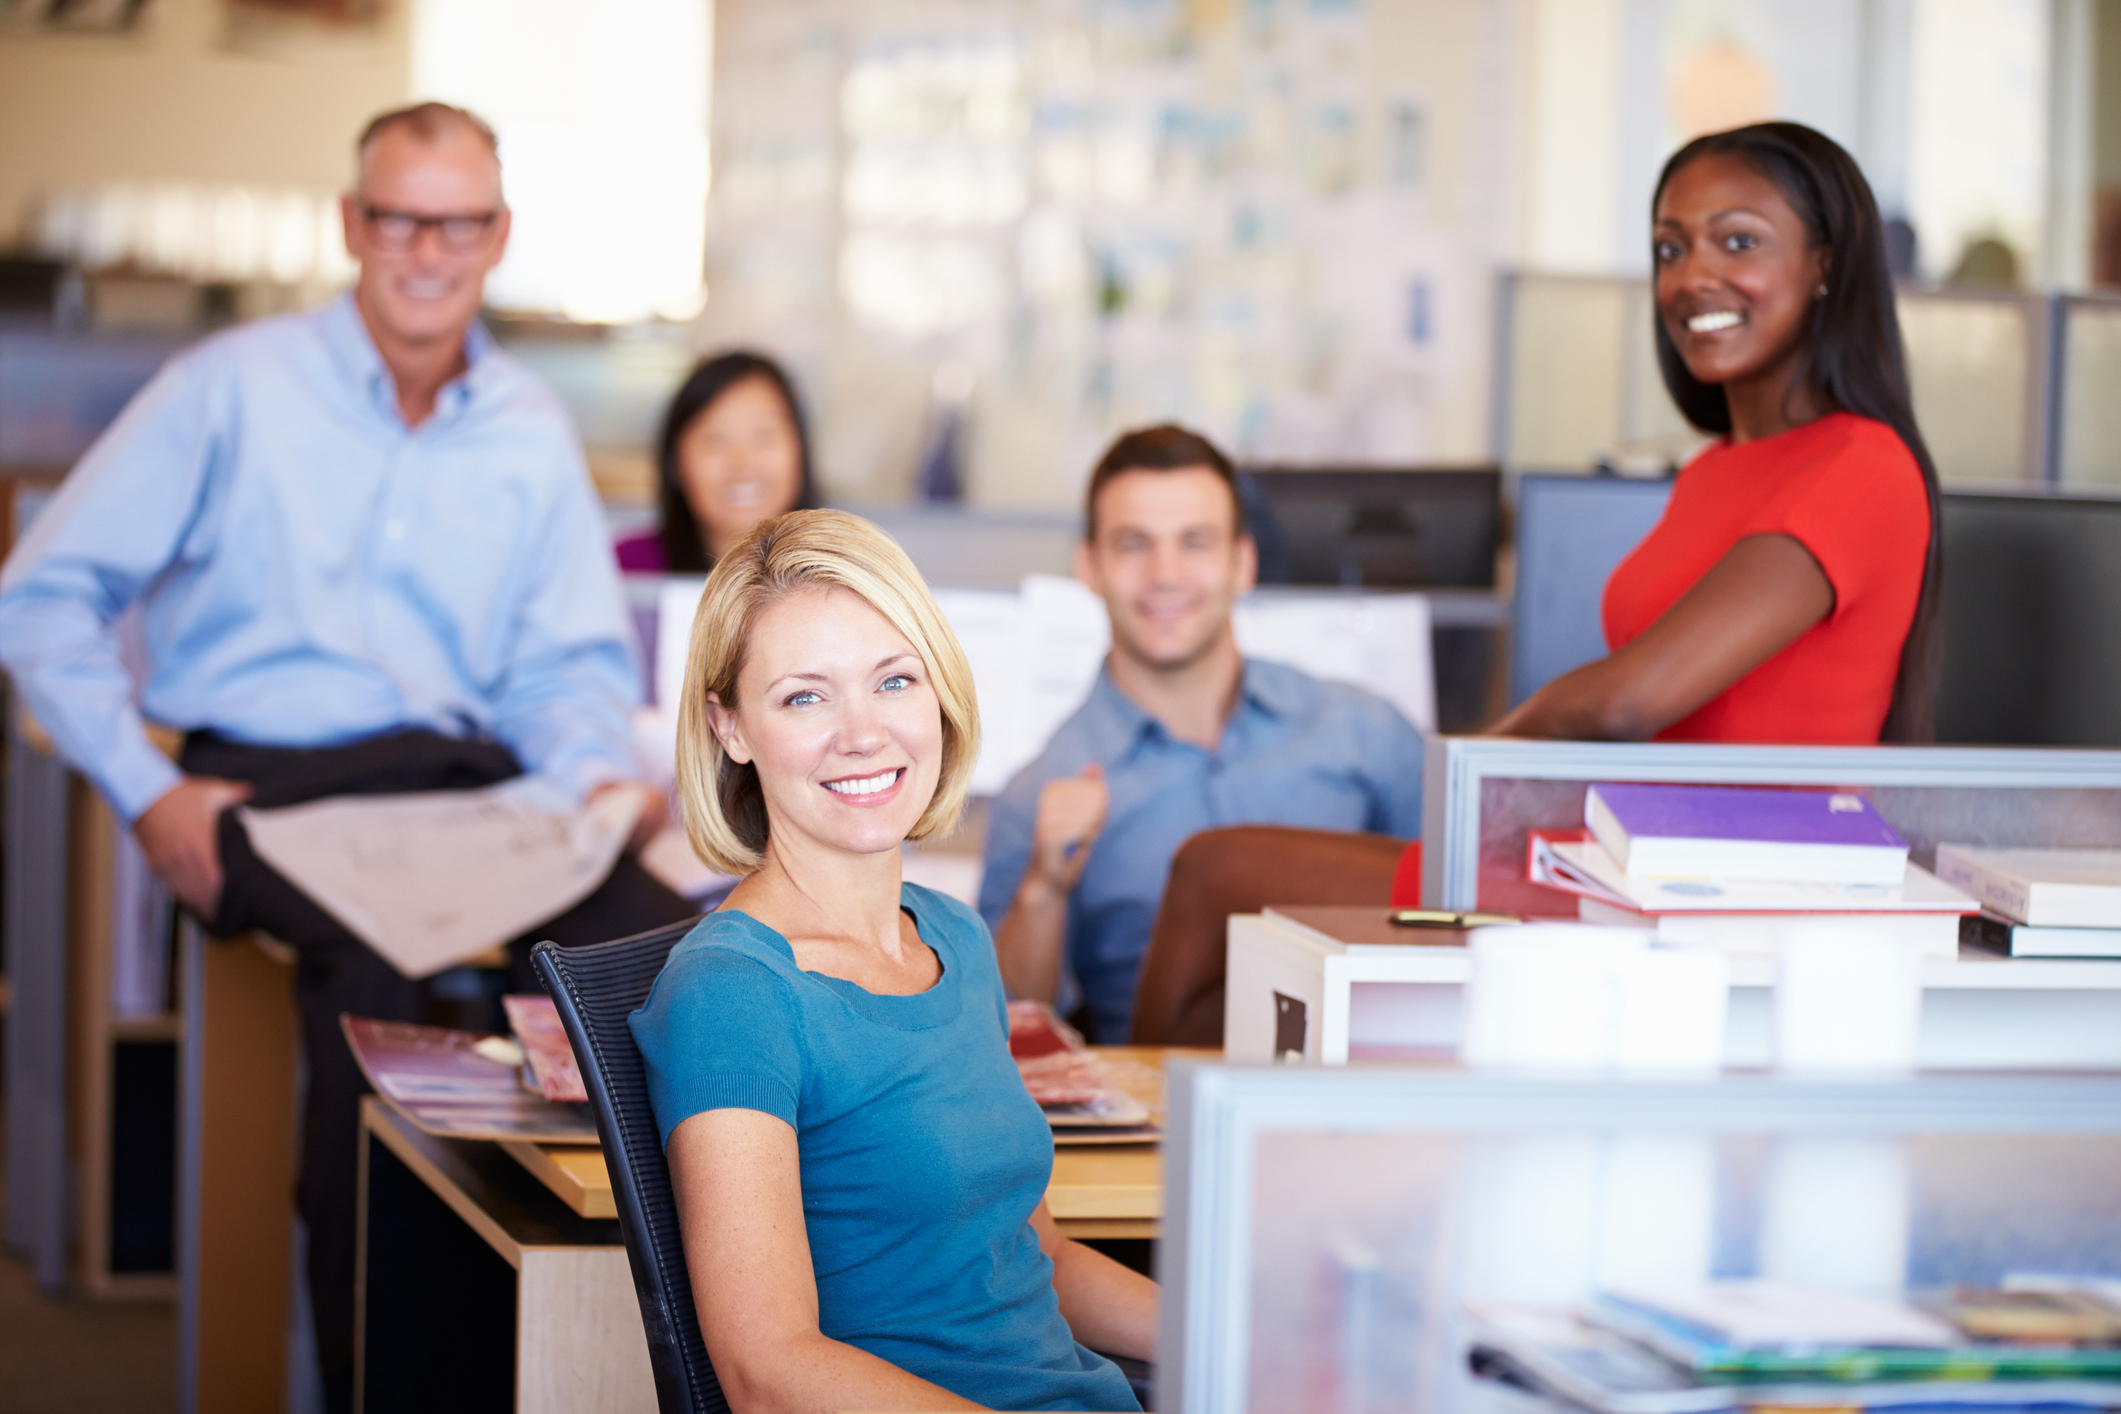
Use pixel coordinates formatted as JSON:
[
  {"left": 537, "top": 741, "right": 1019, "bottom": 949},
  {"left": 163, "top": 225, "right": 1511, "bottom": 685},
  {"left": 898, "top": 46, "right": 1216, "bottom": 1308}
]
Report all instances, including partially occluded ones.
[{"left": 670, "top": 1109, "right": 980, "bottom": 1414}]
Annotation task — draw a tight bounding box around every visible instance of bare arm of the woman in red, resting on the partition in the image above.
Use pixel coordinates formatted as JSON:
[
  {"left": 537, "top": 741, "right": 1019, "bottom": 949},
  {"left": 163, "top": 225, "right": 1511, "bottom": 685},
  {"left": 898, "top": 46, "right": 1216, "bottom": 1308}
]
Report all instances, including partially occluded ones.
[{"left": 1487, "top": 534, "right": 1835, "bottom": 742}]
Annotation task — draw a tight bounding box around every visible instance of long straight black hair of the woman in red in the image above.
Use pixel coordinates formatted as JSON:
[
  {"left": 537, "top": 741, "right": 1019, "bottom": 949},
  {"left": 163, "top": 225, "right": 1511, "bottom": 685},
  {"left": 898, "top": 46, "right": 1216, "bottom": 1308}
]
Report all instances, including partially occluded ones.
[{"left": 1650, "top": 123, "right": 1945, "bottom": 742}]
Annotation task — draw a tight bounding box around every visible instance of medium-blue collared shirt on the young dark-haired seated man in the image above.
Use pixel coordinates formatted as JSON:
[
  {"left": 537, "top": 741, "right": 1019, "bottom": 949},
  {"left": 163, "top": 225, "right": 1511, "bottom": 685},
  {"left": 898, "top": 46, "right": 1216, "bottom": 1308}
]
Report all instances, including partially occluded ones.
[{"left": 980, "top": 659, "right": 1421, "bottom": 1043}]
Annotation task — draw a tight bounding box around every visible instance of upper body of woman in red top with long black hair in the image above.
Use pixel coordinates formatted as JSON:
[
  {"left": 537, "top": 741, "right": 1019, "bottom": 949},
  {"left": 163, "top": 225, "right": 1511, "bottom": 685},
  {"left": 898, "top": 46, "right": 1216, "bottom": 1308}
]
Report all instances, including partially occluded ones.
[{"left": 1491, "top": 123, "right": 1941, "bottom": 744}]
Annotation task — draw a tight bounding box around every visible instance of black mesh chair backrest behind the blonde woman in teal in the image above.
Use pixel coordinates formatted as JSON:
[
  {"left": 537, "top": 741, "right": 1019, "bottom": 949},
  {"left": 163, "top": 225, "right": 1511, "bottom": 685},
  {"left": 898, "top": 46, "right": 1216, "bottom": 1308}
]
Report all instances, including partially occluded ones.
[{"left": 530, "top": 922, "right": 730, "bottom": 1414}]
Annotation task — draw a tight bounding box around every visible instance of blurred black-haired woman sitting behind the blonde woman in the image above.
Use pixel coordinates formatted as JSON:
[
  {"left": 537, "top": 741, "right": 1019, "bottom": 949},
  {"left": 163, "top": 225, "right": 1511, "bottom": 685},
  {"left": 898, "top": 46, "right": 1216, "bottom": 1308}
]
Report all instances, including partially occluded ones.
[{"left": 617, "top": 350, "right": 817, "bottom": 575}]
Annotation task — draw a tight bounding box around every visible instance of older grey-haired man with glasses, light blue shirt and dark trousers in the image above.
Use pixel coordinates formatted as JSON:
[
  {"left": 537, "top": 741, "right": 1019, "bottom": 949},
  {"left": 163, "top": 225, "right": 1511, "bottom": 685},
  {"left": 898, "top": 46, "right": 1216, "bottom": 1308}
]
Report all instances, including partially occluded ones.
[{"left": 0, "top": 104, "right": 694, "bottom": 1410}]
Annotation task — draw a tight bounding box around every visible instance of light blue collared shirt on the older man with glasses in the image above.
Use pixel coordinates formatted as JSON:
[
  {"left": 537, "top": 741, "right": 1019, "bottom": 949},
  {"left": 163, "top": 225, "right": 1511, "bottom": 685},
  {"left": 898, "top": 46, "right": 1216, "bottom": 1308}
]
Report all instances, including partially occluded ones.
[{"left": 0, "top": 295, "right": 641, "bottom": 820}]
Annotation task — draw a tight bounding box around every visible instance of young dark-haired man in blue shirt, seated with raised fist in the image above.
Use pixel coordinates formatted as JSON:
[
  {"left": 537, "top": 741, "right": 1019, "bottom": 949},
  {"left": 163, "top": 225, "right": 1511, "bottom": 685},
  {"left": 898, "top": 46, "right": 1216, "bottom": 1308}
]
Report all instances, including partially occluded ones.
[{"left": 980, "top": 426, "right": 1421, "bottom": 1041}]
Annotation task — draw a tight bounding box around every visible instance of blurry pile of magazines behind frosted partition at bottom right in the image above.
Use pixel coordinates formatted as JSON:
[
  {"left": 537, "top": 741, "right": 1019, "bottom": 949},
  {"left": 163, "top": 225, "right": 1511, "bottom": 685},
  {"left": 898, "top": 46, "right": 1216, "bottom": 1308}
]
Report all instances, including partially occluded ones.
[{"left": 1472, "top": 1280, "right": 2121, "bottom": 1414}]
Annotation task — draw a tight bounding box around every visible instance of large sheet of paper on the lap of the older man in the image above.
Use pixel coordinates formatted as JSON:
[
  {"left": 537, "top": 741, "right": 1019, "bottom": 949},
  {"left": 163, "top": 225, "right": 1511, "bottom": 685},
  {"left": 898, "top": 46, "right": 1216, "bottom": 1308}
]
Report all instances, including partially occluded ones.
[{"left": 242, "top": 776, "right": 641, "bottom": 977}]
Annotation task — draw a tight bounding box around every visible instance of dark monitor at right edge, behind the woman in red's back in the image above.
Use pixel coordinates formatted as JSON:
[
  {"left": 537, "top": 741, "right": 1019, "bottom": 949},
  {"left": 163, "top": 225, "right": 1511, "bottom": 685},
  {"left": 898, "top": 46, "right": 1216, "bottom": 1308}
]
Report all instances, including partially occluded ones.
[{"left": 1936, "top": 492, "right": 2121, "bottom": 746}]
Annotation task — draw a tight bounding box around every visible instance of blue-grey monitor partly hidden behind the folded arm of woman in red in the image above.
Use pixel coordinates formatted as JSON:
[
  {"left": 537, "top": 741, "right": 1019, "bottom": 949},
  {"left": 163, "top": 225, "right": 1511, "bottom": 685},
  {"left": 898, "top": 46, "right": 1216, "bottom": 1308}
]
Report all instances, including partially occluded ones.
[{"left": 1510, "top": 473, "right": 1671, "bottom": 706}]
